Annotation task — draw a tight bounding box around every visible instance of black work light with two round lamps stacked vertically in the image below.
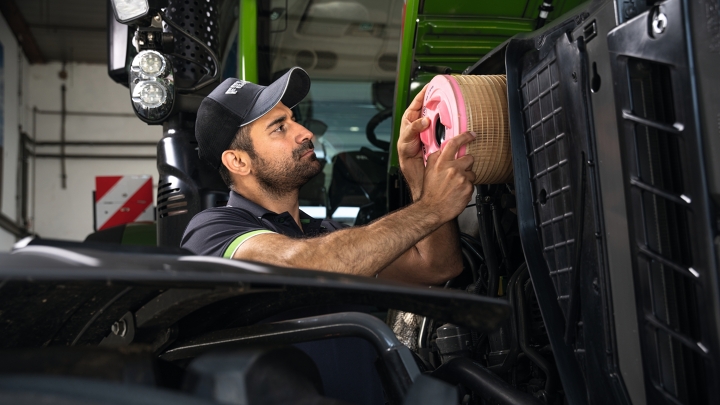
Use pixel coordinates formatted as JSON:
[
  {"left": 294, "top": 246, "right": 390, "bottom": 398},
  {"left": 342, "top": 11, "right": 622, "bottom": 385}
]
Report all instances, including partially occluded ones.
[{"left": 130, "top": 50, "right": 175, "bottom": 124}]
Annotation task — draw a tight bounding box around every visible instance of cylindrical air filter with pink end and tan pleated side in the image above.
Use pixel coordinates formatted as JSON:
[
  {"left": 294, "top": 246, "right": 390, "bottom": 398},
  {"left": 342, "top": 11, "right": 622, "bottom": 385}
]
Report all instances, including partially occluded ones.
[{"left": 420, "top": 75, "right": 513, "bottom": 184}]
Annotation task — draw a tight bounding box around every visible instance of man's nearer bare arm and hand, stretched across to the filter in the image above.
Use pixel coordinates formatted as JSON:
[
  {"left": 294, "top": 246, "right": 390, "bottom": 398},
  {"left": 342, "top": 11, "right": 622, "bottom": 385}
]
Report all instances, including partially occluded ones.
[{"left": 233, "top": 134, "right": 475, "bottom": 285}]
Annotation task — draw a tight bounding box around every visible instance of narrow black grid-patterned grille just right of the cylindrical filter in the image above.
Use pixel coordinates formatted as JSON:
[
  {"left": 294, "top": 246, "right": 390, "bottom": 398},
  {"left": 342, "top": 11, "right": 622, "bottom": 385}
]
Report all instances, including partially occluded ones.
[{"left": 520, "top": 57, "right": 575, "bottom": 316}]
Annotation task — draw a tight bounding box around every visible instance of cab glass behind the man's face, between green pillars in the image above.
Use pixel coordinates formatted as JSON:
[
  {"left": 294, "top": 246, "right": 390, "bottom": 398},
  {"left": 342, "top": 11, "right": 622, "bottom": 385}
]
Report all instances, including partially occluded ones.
[{"left": 258, "top": 0, "right": 403, "bottom": 224}]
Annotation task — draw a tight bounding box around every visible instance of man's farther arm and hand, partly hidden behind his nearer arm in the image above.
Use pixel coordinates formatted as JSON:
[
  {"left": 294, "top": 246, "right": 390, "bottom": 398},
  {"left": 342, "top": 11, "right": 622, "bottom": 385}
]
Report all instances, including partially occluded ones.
[{"left": 378, "top": 86, "right": 470, "bottom": 284}]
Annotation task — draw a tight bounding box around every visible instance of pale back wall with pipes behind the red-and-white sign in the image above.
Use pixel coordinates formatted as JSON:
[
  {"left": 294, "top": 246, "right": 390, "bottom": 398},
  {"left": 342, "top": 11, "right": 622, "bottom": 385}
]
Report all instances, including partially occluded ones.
[{"left": 27, "top": 62, "right": 162, "bottom": 240}]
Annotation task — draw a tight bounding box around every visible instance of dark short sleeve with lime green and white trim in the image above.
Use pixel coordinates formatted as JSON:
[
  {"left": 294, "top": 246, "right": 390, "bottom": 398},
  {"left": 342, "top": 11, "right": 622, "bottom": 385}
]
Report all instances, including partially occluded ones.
[{"left": 180, "top": 207, "right": 273, "bottom": 257}]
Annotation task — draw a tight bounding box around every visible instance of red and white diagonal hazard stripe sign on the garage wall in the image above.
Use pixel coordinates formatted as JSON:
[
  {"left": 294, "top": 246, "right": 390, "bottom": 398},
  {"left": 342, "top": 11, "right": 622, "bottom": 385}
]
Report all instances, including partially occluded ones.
[{"left": 95, "top": 175, "right": 154, "bottom": 231}]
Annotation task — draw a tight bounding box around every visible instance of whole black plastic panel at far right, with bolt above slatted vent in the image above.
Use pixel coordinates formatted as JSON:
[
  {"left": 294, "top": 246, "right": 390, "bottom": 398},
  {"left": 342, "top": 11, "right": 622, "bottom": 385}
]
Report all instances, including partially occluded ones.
[{"left": 608, "top": 0, "right": 720, "bottom": 404}]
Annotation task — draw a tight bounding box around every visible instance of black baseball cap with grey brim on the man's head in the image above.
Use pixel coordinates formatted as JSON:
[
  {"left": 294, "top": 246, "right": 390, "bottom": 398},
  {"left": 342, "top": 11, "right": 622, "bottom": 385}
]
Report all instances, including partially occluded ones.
[{"left": 195, "top": 67, "right": 310, "bottom": 170}]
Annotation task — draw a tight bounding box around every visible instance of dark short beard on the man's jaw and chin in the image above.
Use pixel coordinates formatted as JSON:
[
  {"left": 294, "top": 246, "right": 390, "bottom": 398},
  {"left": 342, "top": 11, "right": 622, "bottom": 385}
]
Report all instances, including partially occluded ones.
[{"left": 254, "top": 141, "right": 322, "bottom": 197}]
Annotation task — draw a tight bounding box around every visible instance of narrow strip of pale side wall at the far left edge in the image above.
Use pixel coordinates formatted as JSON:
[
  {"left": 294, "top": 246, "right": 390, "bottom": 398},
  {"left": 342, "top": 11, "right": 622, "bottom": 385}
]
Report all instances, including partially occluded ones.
[{"left": 0, "top": 11, "right": 28, "bottom": 250}]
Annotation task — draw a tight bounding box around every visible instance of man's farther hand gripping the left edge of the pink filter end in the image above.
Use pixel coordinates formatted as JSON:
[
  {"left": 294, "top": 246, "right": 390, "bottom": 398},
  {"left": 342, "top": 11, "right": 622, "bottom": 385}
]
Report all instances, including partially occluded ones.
[{"left": 397, "top": 85, "right": 430, "bottom": 199}]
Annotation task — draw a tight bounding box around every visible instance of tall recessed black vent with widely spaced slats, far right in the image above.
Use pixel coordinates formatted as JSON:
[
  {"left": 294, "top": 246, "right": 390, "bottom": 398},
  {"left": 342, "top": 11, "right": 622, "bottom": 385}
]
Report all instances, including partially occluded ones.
[{"left": 621, "top": 58, "right": 709, "bottom": 405}]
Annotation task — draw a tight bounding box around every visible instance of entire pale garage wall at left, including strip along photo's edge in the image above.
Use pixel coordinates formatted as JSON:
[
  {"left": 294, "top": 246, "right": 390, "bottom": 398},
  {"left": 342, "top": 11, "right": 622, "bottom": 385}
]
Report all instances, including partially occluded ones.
[{"left": 0, "top": 15, "right": 162, "bottom": 251}]
